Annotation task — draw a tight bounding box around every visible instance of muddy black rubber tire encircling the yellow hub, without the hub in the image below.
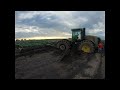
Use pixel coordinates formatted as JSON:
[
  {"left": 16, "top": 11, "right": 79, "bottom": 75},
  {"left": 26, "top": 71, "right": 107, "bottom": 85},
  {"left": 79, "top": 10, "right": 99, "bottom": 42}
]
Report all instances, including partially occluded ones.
[{"left": 78, "top": 40, "right": 95, "bottom": 53}]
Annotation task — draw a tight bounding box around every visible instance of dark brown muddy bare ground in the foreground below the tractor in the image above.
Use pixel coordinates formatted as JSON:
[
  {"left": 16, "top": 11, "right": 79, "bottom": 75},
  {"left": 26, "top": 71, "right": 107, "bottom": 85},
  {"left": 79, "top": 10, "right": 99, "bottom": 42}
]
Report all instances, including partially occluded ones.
[{"left": 15, "top": 47, "right": 105, "bottom": 79}]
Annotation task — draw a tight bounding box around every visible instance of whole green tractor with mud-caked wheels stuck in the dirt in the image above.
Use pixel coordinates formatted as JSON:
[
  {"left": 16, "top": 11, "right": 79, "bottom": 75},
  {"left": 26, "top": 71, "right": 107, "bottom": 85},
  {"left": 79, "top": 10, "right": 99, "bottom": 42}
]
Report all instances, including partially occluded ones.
[{"left": 57, "top": 28, "right": 101, "bottom": 53}]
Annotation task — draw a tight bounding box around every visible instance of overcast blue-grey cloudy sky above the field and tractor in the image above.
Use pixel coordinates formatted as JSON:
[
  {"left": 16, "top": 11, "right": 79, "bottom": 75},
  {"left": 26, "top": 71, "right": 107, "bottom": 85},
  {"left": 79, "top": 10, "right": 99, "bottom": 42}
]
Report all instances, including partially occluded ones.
[{"left": 15, "top": 11, "right": 105, "bottom": 39}]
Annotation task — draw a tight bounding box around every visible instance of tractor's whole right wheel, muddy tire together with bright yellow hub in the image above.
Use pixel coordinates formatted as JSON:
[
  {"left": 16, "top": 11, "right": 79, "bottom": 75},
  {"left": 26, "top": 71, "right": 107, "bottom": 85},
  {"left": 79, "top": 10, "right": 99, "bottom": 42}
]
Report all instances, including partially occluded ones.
[{"left": 78, "top": 40, "right": 95, "bottom": 53}]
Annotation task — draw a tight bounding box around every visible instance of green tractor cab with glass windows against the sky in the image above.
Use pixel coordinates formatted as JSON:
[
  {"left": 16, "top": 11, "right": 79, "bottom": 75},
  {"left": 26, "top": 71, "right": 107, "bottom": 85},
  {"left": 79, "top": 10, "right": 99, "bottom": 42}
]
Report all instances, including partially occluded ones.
[{"left": 71, "top": 28, "right": 85, "bottom": 41}]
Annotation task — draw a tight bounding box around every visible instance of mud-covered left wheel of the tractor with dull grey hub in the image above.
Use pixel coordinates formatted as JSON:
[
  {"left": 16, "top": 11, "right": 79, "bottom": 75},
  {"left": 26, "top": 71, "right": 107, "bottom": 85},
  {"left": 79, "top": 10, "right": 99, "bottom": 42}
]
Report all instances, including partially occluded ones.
[{"left": 57, "top": 40, "right": 70, "bottom": 51}]
